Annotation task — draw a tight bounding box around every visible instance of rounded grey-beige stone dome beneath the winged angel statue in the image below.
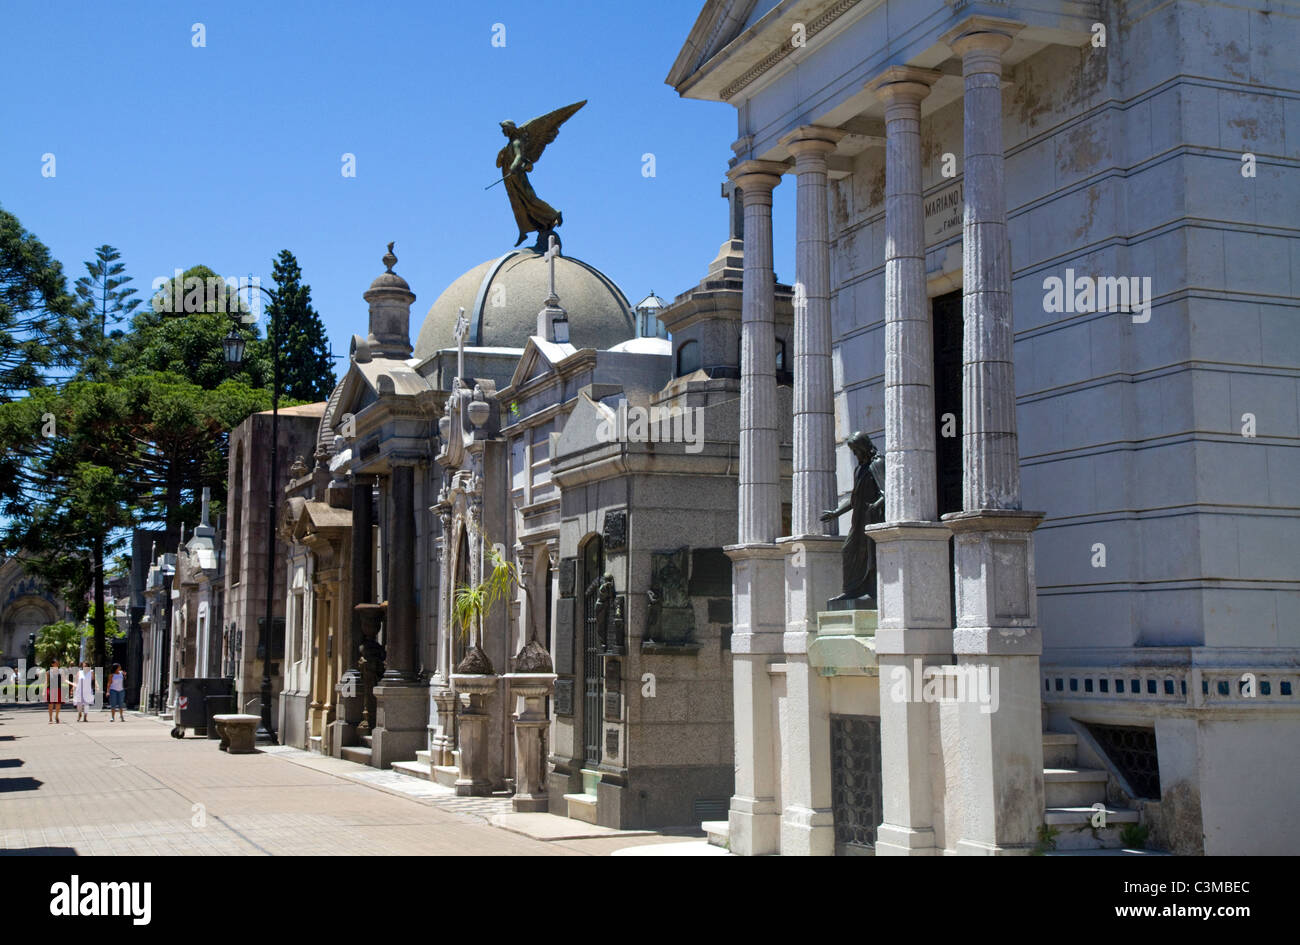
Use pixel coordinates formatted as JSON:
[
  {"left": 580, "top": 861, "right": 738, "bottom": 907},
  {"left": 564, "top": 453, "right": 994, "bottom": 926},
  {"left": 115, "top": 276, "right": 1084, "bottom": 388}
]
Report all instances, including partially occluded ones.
[{"left": 415, "top": 248, "right": 636, "bottom": 361}]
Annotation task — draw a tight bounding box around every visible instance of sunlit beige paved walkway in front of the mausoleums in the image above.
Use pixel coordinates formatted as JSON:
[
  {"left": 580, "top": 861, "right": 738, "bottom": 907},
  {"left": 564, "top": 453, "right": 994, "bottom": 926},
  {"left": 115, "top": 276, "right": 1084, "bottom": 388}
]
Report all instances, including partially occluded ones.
[{"left": 0, "top": 705, "right": 712, "bottom": 855}]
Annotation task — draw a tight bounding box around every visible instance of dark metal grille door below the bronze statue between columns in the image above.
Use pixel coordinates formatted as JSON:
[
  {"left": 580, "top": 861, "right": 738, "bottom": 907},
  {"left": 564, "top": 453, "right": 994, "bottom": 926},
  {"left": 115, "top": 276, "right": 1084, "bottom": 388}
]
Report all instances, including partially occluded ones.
[{"left": 831, "top": 715, "right": 884, "bottom": 857}]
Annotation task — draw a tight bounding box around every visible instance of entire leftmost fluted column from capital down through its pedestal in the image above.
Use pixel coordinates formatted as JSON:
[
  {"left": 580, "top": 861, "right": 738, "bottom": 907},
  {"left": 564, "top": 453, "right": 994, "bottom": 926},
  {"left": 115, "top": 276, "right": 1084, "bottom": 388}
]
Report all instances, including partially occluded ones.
[{"left": 727, "top": 161, "right": 785, "bottom": 855}]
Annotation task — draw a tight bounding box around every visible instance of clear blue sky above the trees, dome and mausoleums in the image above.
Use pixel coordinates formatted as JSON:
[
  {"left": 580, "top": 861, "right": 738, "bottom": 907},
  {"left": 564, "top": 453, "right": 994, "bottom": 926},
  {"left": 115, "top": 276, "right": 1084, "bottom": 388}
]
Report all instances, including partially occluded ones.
[{"left": 0, "top": 0, "right": 794, "bottom": 366}]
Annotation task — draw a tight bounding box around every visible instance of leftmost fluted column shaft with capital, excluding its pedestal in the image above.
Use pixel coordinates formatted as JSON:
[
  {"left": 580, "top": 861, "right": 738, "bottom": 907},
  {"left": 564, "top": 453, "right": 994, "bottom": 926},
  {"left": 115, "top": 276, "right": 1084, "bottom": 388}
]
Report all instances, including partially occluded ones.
[{"left": 728, "top": 161, "right": 785, "bottom": 545}]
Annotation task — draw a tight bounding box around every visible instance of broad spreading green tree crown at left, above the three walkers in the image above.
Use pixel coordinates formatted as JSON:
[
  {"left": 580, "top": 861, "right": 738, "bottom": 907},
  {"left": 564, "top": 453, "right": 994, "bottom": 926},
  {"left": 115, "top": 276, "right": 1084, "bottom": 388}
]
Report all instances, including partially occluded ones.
[{"left": 0, "top": 372, "right": 270, "bottom": 664}]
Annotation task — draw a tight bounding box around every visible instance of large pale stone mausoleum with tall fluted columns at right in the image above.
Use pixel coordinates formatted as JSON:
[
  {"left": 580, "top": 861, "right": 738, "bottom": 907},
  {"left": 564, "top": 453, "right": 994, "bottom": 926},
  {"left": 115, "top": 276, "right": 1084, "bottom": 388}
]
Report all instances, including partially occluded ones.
[{"left": 668, "top": 0, "right": 1300, "bottom": 853}]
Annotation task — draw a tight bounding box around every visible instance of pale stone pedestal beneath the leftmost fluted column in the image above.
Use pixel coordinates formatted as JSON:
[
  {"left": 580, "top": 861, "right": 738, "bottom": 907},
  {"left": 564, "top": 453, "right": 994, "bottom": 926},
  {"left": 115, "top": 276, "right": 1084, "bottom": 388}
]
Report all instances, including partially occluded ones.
[{"left": 725, "top": 543, "right": 785, "bottom": 857}]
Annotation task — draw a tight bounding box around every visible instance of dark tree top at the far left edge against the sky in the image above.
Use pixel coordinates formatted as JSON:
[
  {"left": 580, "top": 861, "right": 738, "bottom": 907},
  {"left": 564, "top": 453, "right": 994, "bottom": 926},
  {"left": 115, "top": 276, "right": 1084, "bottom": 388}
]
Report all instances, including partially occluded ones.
[{"left": 0, "top": 208, "right": 79, "bottom": 402}]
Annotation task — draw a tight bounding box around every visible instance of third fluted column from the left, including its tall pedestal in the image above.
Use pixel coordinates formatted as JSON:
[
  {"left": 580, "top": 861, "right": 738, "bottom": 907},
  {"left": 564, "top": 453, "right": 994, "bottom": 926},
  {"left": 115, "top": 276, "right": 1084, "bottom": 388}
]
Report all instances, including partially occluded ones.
[{"left": 867, "top": 66, "right": 952, "bottom": 855}]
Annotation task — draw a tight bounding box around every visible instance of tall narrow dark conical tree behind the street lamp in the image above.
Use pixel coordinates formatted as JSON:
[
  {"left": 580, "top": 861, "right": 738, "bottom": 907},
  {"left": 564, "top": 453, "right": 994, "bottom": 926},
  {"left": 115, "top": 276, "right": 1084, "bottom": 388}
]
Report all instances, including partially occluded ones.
[{"left": 267, "top": 250, "right": 335, "bottom": 403}]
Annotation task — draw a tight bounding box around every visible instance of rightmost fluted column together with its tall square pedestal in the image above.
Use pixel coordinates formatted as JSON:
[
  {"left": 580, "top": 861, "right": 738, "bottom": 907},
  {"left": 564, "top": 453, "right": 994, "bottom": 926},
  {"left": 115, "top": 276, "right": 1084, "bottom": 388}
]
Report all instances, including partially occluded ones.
[{"left": 944, "top": 17, "right": 1044, "bottom": 855}]
